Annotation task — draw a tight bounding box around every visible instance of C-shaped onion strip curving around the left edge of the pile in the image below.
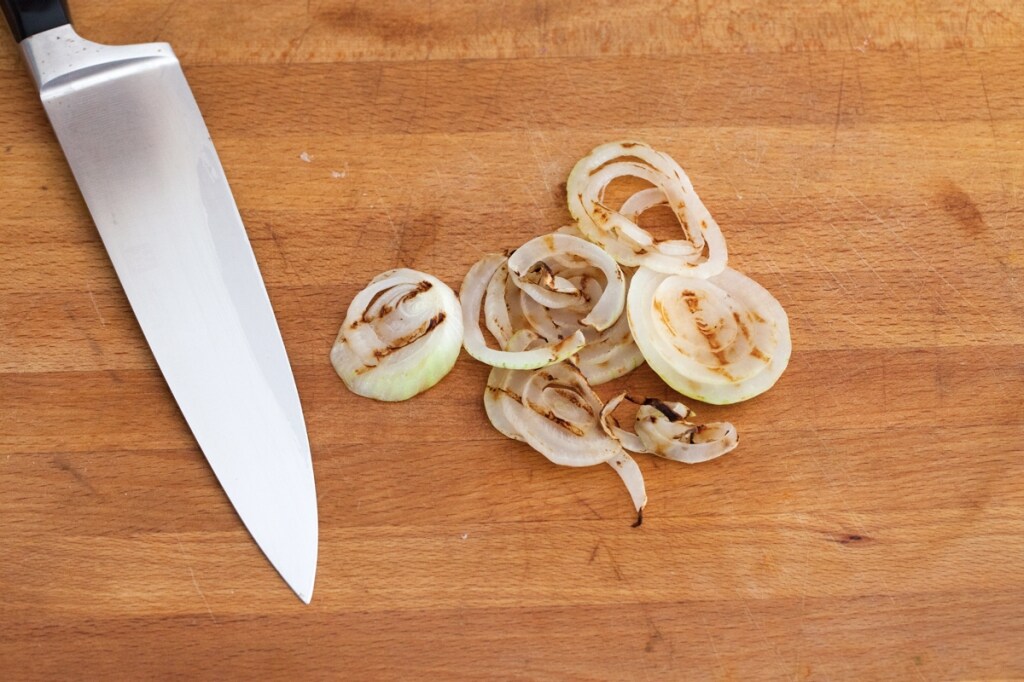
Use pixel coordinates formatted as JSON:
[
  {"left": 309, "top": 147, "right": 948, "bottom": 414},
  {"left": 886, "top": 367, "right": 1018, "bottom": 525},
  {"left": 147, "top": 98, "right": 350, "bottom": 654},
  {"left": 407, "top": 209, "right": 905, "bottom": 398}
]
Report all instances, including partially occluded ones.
[{"left": 460, "top": 254, "right": 586, "bottom": 370}]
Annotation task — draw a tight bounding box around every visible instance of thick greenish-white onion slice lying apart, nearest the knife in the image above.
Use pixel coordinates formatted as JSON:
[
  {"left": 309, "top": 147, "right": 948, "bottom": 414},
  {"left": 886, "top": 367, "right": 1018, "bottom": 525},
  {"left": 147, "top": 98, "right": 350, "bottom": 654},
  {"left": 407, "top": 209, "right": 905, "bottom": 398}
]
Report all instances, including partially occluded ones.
[{"left": 331, "top": 268, "right": 463, "bottom": 400}]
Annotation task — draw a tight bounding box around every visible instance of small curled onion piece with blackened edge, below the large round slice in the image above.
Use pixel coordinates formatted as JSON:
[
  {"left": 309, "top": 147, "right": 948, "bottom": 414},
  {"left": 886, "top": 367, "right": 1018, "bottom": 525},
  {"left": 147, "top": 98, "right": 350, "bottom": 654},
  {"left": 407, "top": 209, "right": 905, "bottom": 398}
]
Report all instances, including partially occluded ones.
[{"left": 601, "top": 393, "right": 739, "bottom": 464}]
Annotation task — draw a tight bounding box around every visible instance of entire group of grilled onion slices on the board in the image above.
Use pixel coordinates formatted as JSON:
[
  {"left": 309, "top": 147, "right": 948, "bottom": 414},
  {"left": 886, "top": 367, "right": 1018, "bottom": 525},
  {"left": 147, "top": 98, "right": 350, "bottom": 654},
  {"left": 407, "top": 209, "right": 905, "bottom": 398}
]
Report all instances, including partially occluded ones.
[{"left": 331, "top": 141, "right": 792, "bottom": 525}]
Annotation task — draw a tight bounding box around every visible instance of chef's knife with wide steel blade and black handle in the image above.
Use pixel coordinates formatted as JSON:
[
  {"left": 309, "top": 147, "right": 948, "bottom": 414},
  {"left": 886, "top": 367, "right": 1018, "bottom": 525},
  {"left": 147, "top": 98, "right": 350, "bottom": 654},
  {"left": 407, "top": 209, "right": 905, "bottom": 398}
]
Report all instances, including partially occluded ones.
[{"left": 0, "top": 0, "right": 317, "bottom": 603}]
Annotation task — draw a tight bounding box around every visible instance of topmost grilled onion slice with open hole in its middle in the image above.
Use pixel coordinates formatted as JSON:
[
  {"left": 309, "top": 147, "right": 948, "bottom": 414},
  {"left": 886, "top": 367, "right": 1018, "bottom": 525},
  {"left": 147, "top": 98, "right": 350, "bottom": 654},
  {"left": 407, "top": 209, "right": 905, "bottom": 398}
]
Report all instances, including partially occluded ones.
[{"left": 566, "top": 141, "right": 728, "bottom": 278}]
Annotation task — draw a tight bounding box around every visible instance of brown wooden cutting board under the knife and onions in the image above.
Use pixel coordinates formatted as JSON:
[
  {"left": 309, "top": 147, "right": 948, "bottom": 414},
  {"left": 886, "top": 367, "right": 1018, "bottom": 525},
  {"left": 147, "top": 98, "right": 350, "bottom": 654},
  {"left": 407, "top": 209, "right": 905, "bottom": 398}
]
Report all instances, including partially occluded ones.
[{"left": 0, "top": 0, "right": 1024, "bottom": 680}]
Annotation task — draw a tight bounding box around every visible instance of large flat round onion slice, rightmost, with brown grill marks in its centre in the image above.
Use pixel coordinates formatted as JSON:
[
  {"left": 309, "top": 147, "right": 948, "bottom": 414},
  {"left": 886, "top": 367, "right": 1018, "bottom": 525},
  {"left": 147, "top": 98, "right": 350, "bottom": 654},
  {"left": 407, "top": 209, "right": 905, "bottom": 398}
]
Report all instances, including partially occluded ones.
[{"left": 627, "top": 267, "right": 793, "bottom": 404}]
